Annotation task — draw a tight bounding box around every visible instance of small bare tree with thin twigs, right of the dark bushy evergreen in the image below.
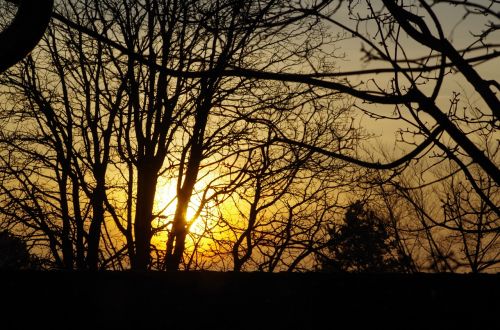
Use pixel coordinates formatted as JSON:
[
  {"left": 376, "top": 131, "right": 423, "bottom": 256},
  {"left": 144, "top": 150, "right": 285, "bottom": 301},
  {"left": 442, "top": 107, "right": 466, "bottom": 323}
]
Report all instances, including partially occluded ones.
[{"left": 389, "top": 159, "right": 499, "bottom": 273}]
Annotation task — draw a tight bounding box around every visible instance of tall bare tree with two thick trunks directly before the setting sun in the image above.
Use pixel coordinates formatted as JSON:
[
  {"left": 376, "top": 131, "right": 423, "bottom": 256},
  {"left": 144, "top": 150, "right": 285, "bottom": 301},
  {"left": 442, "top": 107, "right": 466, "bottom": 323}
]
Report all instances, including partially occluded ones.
[{"left": 100, "top": 1, "right": 344, "bottom": 269}]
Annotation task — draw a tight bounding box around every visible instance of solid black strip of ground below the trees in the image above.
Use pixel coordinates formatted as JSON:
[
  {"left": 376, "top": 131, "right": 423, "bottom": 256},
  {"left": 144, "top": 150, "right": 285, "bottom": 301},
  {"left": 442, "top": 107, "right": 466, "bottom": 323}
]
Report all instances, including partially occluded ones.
[{"left": 0, "top": 272, "right": 500, "bottom": 330}]
